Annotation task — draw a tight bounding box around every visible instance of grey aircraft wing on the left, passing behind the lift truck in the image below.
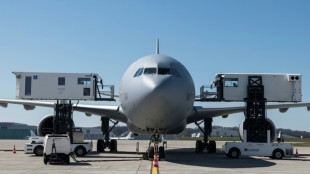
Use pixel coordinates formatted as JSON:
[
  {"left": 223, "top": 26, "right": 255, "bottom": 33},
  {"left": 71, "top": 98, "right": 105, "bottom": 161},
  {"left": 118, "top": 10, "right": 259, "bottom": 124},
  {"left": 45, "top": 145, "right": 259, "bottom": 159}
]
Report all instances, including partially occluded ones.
[{"left": 0, "top": 99, "right": 127, "bottom": 123}]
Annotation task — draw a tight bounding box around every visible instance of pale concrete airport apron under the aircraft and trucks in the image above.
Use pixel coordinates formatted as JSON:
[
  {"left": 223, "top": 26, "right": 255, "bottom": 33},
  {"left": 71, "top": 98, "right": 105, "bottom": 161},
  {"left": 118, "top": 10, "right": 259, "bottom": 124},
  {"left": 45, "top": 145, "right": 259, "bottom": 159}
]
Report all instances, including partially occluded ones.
[{"left": 0, "top": 140, "right": 310, "bottom": 174}]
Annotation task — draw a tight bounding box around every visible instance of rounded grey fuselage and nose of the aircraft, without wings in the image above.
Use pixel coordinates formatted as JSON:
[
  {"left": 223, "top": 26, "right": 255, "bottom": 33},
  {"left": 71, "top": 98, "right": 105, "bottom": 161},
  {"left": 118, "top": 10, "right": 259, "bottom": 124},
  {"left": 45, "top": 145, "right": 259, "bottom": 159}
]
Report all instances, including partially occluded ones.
[{"left": 119, "top": 54, "right": 195, "bottom": 134}]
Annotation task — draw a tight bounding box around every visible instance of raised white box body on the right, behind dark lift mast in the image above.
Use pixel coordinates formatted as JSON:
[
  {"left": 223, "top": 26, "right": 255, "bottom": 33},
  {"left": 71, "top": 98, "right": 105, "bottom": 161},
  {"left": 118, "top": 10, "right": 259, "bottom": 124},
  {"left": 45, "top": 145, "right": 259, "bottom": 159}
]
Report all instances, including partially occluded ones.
[{"left": 216, "top": 74, "right": 302, "bottom": 102}]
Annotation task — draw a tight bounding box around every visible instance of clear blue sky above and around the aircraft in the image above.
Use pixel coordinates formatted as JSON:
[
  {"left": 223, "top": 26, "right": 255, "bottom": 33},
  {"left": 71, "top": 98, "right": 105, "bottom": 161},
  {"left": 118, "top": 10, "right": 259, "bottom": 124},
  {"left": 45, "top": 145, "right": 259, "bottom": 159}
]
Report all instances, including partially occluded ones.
[{"left": 0, "top": 0, "right": 310, "bottom": 131}]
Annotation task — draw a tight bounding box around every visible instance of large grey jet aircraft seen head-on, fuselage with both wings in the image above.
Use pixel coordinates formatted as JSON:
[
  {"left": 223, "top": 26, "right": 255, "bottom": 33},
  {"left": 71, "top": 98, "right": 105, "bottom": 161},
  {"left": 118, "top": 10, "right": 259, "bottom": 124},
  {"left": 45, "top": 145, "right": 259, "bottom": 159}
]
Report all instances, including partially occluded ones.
[{"left": 0, "top": 40, "right": 310, "bottom": 159}]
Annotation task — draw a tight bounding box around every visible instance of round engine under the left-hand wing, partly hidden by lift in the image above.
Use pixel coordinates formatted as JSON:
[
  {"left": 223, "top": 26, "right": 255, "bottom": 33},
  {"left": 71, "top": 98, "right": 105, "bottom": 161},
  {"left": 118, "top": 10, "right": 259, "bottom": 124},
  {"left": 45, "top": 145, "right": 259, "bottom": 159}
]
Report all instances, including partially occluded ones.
[{"left": 37, "top": 114, "right": 75, "bottom": 136}]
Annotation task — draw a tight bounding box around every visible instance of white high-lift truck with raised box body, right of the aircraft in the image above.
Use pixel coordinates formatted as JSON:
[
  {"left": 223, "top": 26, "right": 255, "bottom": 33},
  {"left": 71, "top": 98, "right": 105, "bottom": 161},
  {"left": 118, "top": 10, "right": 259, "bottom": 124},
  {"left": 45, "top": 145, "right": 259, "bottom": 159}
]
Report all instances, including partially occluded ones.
[{"left": 197, "top": 73, "right": 302, "bottom": 159}]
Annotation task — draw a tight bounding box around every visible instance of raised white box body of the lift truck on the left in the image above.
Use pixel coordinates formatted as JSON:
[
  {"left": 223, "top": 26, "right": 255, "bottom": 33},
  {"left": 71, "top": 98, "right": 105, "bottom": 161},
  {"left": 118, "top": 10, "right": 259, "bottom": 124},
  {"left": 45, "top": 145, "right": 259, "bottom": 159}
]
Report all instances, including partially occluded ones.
[{"left": 13, "top": 72, "right": 98, "bottom": 100}]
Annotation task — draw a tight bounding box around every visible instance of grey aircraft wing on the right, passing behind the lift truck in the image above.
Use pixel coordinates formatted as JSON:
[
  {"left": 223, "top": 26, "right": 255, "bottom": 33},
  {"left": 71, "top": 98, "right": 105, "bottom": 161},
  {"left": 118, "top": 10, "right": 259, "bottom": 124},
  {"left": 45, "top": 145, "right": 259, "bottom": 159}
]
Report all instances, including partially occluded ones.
[{"left": 187, "top": 103, "right": 310, "bottom": 124}]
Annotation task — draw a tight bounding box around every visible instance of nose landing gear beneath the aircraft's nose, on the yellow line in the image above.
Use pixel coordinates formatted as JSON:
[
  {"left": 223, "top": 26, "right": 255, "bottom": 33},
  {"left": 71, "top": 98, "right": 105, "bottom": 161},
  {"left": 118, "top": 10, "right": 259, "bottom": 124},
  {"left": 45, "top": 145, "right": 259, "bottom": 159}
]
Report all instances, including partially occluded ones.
[{"left": 143, "top": 133, "right": 167, "bottom": 160}]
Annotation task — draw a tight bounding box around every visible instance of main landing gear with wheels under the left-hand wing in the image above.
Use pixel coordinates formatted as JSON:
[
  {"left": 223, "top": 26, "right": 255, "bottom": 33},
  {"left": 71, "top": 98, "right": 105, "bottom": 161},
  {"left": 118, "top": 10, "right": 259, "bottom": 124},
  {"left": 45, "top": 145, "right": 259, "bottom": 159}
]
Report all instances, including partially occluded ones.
[{"left": 97, "top": 117, "right": 118, "bottom": 152}]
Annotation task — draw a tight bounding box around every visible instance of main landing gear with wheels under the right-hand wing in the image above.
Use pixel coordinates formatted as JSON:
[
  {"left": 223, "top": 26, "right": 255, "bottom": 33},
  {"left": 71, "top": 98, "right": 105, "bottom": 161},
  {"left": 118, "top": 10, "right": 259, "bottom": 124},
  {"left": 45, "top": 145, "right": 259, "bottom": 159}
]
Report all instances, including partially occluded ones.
[{"left": 195, "top": 118, "right": 216, "bottom": 153}]
